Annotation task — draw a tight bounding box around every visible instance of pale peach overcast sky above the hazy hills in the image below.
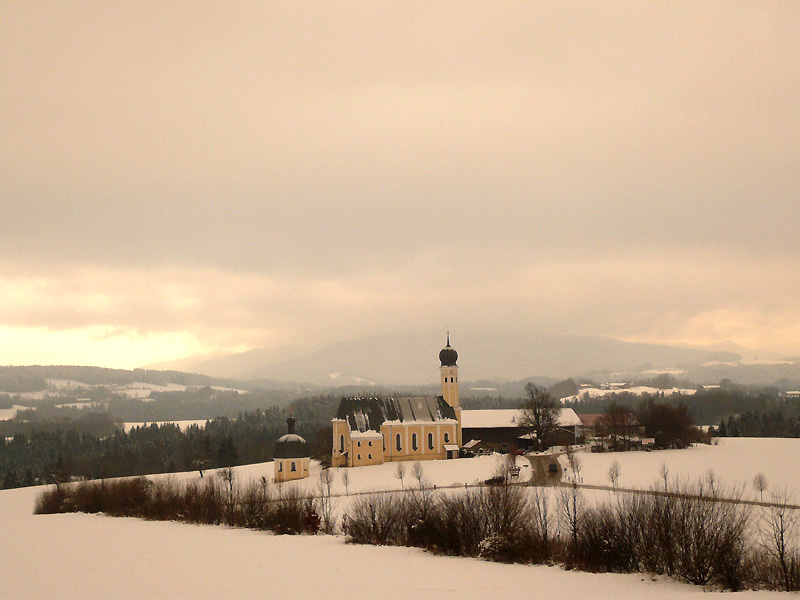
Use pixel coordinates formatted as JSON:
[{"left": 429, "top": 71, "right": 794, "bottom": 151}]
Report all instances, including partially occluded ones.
[{"left": 0, "top": 0, "right": 800, "bottom": 368}]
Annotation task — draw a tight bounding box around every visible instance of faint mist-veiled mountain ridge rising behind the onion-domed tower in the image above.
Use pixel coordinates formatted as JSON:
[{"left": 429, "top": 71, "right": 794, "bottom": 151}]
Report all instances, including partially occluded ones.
[{"left": 148, "top": 332, "right": 800, "bottom": 386}]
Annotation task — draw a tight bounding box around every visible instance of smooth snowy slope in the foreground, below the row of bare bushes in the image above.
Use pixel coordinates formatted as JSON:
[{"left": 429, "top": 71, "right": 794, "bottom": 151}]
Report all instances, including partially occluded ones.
[{"left": 0, "top": 488, "right": 779, "bottom": 600}]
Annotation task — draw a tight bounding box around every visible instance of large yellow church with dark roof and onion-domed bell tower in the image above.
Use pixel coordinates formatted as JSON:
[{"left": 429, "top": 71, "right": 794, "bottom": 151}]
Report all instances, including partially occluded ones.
[{"left": 331, "top": 332, "right": 462, "bottom": 467}]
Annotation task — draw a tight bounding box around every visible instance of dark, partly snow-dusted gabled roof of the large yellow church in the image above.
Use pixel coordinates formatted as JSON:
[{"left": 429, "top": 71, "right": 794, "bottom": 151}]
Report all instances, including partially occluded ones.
[{"left": 336, "top": 396, "right": 456, "bottom": 432}]
